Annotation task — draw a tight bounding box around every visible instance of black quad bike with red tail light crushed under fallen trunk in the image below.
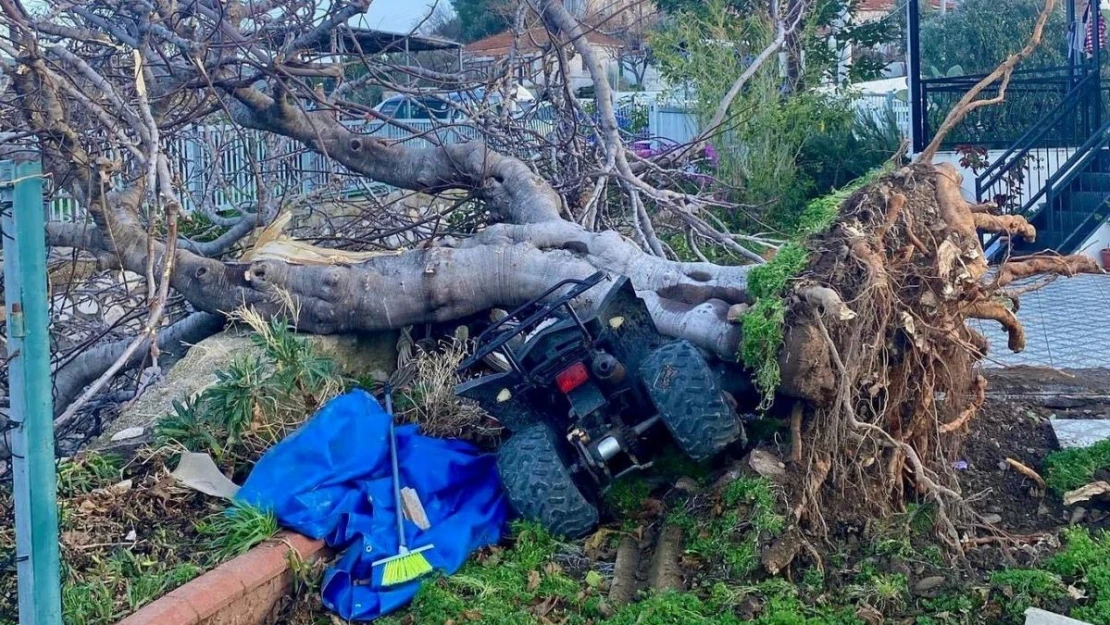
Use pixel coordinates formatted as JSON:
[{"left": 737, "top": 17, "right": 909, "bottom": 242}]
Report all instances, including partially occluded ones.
[{"left": 455, "top": 273, "right": 745, "bottom": 537}]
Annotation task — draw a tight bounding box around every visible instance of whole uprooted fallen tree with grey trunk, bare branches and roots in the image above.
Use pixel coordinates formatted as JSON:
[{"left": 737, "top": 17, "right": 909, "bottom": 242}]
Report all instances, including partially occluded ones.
[{"left": 0, "top": 0, "right": 1098, "bottom": 547}]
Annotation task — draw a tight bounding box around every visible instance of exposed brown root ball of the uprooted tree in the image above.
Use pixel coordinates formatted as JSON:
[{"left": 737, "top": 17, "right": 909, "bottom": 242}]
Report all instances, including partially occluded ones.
[{"left": 780, "top": 164, "right": 1100, "bottom": 550}]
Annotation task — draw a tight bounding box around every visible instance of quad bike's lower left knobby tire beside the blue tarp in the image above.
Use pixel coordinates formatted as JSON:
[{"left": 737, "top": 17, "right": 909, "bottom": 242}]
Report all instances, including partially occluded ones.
[{"left": 497, "top": 424, "right": 597, "bottom": 538}]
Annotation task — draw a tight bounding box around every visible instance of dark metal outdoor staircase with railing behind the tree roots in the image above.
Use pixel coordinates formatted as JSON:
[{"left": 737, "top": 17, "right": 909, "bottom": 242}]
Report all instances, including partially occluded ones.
[{"left": 976, "top": 70, "right": 1110, "bottom": 259}]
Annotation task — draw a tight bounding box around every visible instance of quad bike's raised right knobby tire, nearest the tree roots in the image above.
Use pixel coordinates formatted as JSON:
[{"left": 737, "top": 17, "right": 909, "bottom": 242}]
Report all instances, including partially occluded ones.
[{"left": 639, "top": 341, "right": 744, "bottom": 461}]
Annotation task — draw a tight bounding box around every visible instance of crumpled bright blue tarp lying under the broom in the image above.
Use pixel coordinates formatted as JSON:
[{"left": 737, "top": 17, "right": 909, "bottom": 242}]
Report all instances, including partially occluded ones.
[{"left": 236, "top": 391, "right": 508, "bottom": 621}]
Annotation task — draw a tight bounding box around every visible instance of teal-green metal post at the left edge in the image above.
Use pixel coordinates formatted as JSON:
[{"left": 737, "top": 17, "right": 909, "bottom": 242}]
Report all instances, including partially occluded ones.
[{"left": 0, "top": 161, "right": 62, "bottom": 625}]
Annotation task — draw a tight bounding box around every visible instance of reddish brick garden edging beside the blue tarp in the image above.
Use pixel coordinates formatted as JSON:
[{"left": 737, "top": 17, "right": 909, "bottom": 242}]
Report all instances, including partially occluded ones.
[{"left": 117, "top": 532, "right": 324, "bottom": 625}]
